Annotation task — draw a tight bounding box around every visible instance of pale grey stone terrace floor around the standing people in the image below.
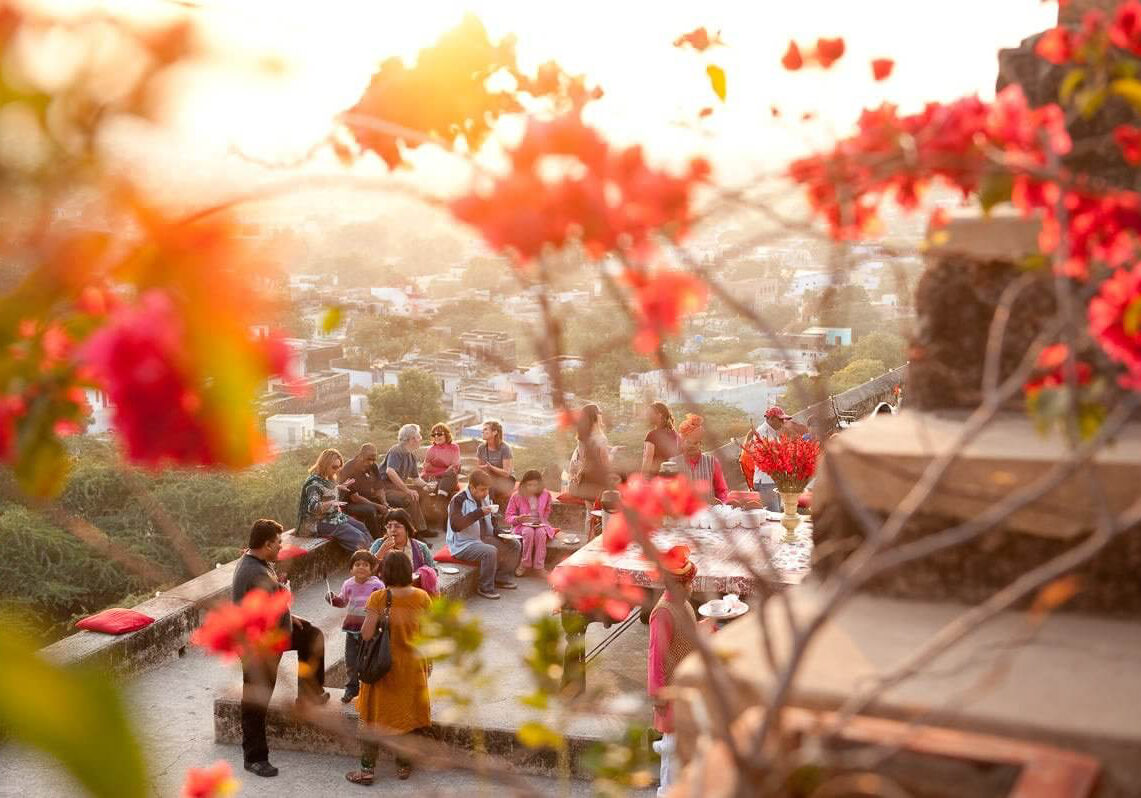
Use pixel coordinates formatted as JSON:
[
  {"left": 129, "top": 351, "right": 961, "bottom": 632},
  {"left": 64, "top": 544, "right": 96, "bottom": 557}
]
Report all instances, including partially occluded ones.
[{"left": 0, "top": 563, "right": 653, "bottom": 798}]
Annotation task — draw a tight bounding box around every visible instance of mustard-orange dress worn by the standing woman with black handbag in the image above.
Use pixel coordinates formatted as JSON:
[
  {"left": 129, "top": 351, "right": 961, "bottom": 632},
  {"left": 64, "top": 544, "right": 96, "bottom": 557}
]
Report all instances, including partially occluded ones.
[{"left": 357, "top": 588, "right": 431, "bottom": 734}]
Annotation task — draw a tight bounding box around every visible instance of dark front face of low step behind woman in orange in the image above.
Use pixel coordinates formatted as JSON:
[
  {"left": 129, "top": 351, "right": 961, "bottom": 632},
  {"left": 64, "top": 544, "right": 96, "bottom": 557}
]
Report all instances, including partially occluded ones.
[{"left": 213, "top": 677, "right": 601, "bottom": 779}]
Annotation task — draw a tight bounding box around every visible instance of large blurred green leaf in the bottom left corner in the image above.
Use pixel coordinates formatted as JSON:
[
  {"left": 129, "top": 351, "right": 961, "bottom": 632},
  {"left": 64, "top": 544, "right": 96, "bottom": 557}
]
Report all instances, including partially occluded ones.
[{"left": 0, "top": 623, "right": 148, "bottom": 798}]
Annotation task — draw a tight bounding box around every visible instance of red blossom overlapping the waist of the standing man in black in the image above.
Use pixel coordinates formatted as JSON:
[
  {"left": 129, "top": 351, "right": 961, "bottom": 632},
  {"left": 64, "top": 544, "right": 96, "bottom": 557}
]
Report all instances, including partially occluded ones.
[{"left": 191, "top": 589, "right": 293, "bottom": 659}]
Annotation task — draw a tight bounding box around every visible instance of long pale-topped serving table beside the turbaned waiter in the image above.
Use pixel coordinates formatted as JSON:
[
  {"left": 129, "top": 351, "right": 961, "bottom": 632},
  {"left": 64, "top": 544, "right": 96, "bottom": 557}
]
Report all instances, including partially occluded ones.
[{"left": 555, "top": 510, "right": 812, "bottom": 694}]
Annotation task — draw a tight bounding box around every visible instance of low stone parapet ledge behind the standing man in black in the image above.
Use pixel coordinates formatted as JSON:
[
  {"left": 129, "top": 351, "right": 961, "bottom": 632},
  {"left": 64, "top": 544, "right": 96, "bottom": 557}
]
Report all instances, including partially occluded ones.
[{"left": 40, "top": 531, "right": 348, "bottom": 674}]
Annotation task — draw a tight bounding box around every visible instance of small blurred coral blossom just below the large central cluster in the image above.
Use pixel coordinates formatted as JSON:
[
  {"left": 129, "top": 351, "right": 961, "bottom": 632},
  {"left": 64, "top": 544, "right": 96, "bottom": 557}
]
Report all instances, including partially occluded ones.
[{"left": 622, "top": 269, "right": 709, "bottom": 354}]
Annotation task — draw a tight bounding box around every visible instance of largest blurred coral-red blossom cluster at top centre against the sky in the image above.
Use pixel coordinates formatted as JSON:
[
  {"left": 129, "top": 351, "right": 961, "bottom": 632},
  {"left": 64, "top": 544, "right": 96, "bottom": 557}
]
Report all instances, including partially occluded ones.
[{"left": 451, "top": 113, "right": 710, "bottom": 263}]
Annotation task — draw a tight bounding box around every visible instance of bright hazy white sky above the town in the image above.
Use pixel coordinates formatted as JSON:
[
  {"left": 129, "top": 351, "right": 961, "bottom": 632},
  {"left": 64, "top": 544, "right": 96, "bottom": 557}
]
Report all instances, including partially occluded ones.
[{"left": 49, "top": 0, "right": 1057, "bottom": 215}]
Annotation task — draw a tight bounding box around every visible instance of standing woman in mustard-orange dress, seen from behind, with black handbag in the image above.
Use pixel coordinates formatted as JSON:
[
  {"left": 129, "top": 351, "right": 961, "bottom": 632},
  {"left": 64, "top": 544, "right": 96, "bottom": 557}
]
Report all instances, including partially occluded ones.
[{"left": 345, "top": 551, "right": 431, "bottom": 784}]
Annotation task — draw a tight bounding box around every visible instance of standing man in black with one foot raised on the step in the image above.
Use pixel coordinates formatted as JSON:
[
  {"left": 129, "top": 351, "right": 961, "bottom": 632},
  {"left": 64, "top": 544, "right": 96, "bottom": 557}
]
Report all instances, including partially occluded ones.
[{"left": 233, "top": 518, "right": 329, "bottom": 776}]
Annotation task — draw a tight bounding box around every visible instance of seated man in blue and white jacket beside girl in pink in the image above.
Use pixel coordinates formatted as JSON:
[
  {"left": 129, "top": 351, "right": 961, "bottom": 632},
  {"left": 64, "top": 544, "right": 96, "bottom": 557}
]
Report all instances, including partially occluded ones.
[{"left": 447, "top": 471, "right": 520, "bottom": 598}]
